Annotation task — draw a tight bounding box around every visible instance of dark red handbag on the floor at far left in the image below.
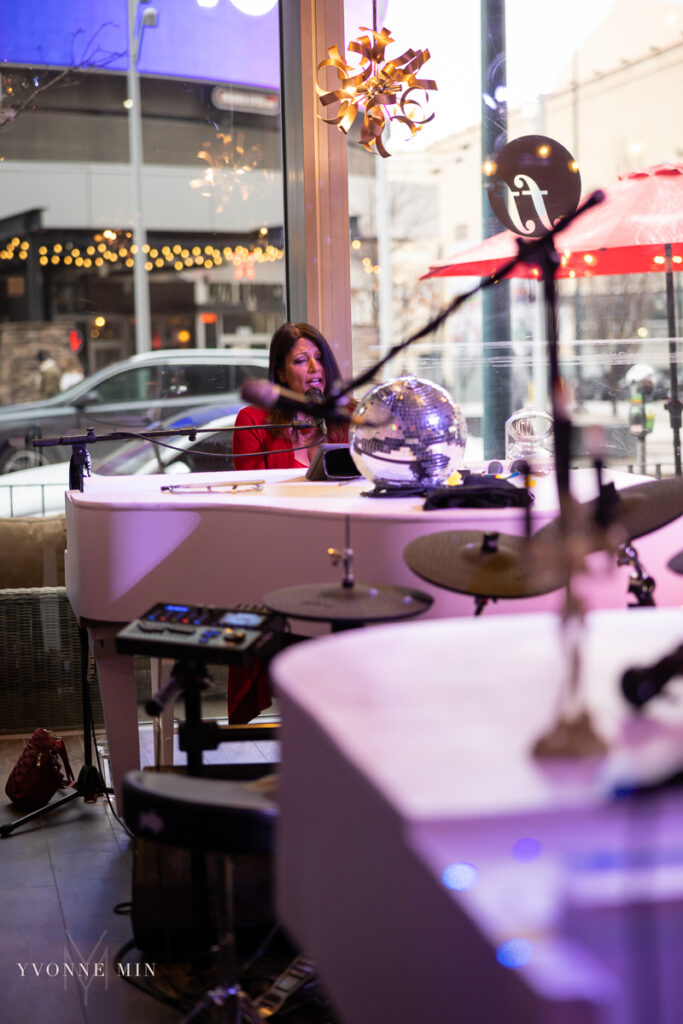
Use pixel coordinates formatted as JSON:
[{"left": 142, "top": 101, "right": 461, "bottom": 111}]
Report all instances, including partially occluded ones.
[{"left": 5, "top": 729, "right": 74, "bottom": 811}]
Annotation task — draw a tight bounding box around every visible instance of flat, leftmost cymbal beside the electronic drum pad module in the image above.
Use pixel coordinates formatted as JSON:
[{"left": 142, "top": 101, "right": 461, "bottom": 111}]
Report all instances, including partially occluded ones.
[{"left": 263, "top": 583, "right": 433, "bottom": 624}]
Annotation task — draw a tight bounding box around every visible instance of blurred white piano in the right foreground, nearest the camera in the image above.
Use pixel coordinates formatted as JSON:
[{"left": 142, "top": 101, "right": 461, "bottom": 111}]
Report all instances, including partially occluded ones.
[{"left": 271, "top": 608, "right": 683, "bottom": 1024}]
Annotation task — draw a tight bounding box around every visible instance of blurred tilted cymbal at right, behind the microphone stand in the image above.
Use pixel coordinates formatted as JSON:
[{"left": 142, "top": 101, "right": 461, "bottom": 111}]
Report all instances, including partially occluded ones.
[{"left": 533, "top": 476, "right": 683, "bottom": 551}]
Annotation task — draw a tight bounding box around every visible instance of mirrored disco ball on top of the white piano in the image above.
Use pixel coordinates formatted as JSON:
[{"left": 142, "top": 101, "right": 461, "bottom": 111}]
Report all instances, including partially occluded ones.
[{"left": 349, "top": 377, "right": 467, "bottom": 487}]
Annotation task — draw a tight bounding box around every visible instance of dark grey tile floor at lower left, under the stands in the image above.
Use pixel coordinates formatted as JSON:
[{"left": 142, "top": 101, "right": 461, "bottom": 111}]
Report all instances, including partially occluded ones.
[{"left": 0, "top": 712, "right": 329, "bottom": 1024}]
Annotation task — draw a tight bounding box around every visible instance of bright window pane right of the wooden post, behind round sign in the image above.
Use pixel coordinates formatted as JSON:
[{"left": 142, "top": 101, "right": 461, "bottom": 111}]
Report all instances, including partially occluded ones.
[{"left": 348, "top": 0, "right": 683, "bottom": 474}]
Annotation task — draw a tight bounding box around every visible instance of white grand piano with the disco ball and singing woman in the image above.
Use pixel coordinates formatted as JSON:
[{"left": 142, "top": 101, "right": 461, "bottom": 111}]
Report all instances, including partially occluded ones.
[{"left": 66, "top": 467, "right": 680, "bottom": 795}]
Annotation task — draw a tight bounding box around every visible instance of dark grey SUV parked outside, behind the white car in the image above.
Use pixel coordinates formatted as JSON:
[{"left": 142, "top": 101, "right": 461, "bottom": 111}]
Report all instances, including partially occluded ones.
[{"left": 0, "top": 348, "right": 268, "bottom": 473}]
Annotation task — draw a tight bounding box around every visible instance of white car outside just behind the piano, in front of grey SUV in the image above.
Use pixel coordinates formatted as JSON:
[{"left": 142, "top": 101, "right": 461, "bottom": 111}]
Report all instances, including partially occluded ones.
[{"left": 0, "top": 402, "right": 244, "bottom": 517}]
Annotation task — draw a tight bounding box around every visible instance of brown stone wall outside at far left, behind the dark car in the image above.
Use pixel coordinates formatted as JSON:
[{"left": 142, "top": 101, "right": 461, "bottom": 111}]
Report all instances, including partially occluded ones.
[{"left": 0, "top": 324, "right": 73, "bottom": 406}]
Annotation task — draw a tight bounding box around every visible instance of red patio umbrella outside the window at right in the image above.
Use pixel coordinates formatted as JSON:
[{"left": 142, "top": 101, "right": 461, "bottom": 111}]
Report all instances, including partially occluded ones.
[{"left": 421, "top": 164, "right": 683, "bottom": 474}]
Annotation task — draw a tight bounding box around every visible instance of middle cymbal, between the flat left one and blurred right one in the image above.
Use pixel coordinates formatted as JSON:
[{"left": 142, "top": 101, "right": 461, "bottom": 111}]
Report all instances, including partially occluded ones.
[{"left": 403, "top": 529, "right": 566, "bottom": 598}]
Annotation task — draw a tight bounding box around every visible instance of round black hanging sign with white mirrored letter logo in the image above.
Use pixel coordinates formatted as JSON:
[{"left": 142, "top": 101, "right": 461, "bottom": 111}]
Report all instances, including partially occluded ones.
[{"left": 484, "top": 135, "right": 581, "bottom": 238}]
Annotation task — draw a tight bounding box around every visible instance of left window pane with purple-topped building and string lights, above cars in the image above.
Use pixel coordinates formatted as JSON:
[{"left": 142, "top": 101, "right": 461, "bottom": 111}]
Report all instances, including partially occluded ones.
[{"left": 0, "top": 0, "right": 286, "bottom": 404}]
